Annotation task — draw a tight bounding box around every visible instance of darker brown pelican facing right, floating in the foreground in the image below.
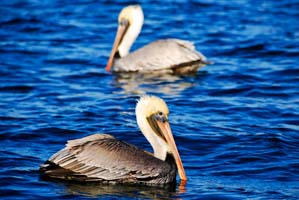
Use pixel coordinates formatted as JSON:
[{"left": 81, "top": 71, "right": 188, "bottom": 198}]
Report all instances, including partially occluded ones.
[{"left": 40, "top": 96, "right": 187, "bottom": 185}]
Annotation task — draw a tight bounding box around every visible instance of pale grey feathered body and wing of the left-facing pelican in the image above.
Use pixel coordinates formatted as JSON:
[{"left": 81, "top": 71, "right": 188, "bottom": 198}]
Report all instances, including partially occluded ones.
[{"left": 113, "top": 39, "right": 207, "bottom": 72}]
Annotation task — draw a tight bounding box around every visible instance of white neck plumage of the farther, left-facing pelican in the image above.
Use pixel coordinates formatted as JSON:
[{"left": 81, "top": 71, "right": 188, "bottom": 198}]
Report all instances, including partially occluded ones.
[{"left": 118, "top": 9, "right": 144, "bottom": 57}]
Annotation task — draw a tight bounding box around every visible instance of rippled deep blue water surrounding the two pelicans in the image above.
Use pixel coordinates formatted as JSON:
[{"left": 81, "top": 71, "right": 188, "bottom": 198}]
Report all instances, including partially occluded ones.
[{"left": 0, "top": 0, "right": 299, "bottom": 199}]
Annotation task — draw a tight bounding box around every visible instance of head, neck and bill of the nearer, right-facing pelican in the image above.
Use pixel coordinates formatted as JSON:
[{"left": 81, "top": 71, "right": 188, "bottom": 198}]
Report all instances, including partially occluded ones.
[{"left": 136, "top": 96, "right": 187, "bottom": 180}]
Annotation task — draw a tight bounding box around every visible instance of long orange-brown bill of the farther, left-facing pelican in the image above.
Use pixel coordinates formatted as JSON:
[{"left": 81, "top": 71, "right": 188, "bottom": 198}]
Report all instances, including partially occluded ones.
[{"left": 106, "top": 19, "right": 129, "bottom": 72}]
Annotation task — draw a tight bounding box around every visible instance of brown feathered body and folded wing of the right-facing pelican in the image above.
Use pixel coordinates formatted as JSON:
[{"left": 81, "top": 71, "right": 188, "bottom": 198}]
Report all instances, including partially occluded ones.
[{"left": 42, "top": 134, "right": 173, "bottom": 182}]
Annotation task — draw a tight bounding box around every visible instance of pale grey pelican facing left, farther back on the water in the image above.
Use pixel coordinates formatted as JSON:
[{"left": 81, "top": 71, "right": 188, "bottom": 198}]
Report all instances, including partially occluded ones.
[{"left": 106, "top": 5, "right": 210, "bottom": 74}]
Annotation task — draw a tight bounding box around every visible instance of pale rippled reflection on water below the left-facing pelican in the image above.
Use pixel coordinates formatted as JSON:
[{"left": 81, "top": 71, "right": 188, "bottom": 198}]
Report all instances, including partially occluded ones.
[{"left": 114, "top": 72, "right": 204, "bottom": 95}]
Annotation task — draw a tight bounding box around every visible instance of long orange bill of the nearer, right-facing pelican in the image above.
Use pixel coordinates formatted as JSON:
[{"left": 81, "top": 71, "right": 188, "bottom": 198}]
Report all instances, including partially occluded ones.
[{"left": 156, "top": 117, "right": 187, "bottom": 181}]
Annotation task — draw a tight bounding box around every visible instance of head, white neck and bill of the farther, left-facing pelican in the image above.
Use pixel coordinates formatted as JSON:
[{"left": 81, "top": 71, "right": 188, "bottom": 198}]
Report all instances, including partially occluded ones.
[{"left": 106, "top": 5, "right": 144, "bottom": 71}]
